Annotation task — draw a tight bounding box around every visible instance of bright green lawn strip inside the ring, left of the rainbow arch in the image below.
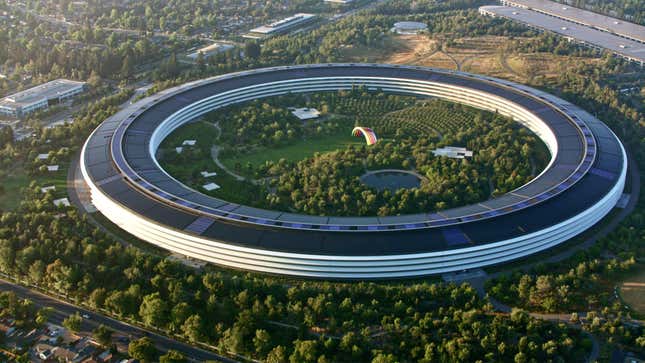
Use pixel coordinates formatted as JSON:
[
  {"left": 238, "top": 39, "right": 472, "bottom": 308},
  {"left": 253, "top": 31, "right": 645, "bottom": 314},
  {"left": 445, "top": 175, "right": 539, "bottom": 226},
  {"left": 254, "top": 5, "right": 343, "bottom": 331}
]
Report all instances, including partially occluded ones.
[{"left": 221, "top": 129, "right": 365, "bottom": 170}]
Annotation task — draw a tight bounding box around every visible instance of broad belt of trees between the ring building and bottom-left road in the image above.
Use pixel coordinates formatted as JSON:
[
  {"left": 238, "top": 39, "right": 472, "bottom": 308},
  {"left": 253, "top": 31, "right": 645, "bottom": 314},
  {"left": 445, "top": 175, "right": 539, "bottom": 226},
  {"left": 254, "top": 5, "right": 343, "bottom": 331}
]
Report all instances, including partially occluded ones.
[{"left": 0, "top": 190, "right": 586, "bottom": 362}]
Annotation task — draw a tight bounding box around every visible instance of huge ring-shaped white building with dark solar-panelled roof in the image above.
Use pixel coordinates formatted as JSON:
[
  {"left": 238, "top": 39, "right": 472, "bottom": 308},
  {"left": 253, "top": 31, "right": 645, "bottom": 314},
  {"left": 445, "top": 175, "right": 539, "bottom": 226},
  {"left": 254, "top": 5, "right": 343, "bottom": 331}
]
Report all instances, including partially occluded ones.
[{"left": 81, "top": 64, "right": 627, "bottom": 279}]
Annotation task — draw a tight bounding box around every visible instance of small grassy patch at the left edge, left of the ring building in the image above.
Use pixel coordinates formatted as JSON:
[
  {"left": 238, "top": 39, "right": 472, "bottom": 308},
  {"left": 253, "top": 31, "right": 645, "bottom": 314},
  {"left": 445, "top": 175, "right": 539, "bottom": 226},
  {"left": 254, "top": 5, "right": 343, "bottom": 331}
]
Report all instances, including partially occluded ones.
[{"left": 0, "top": 163, "right": 68, "bottom": 211}]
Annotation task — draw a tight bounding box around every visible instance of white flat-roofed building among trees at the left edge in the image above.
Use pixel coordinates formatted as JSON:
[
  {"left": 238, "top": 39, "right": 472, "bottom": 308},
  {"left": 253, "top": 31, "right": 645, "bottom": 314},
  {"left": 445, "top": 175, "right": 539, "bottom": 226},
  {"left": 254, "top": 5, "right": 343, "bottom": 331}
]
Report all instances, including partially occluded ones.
[{"left": 0, "top": 79, "right": 86, "bottom": 117}]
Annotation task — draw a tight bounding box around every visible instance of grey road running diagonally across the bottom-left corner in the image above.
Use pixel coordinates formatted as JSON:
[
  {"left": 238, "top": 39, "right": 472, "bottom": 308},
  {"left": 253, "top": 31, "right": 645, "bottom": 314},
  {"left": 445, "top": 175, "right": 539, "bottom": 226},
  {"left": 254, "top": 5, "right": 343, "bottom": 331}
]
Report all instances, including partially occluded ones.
[{"left": 0, "top": 279, "right": 237, "bottom": 363}]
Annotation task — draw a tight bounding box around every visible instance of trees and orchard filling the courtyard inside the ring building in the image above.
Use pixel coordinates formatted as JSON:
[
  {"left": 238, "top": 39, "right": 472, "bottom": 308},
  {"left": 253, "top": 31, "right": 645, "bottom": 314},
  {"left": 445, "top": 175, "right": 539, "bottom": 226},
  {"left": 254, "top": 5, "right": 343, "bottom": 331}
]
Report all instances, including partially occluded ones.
[{"left": 161, "top": 88, "right": 548, "bottom": 216}]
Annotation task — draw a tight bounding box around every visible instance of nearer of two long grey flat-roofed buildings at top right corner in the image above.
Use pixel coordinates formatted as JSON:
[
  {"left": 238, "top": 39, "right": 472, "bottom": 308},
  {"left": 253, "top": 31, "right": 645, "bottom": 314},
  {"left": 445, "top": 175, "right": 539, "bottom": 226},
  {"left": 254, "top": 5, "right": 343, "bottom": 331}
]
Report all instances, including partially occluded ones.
[{"left": 479, "top": 5, "right": 645, "bottom": 66}]
